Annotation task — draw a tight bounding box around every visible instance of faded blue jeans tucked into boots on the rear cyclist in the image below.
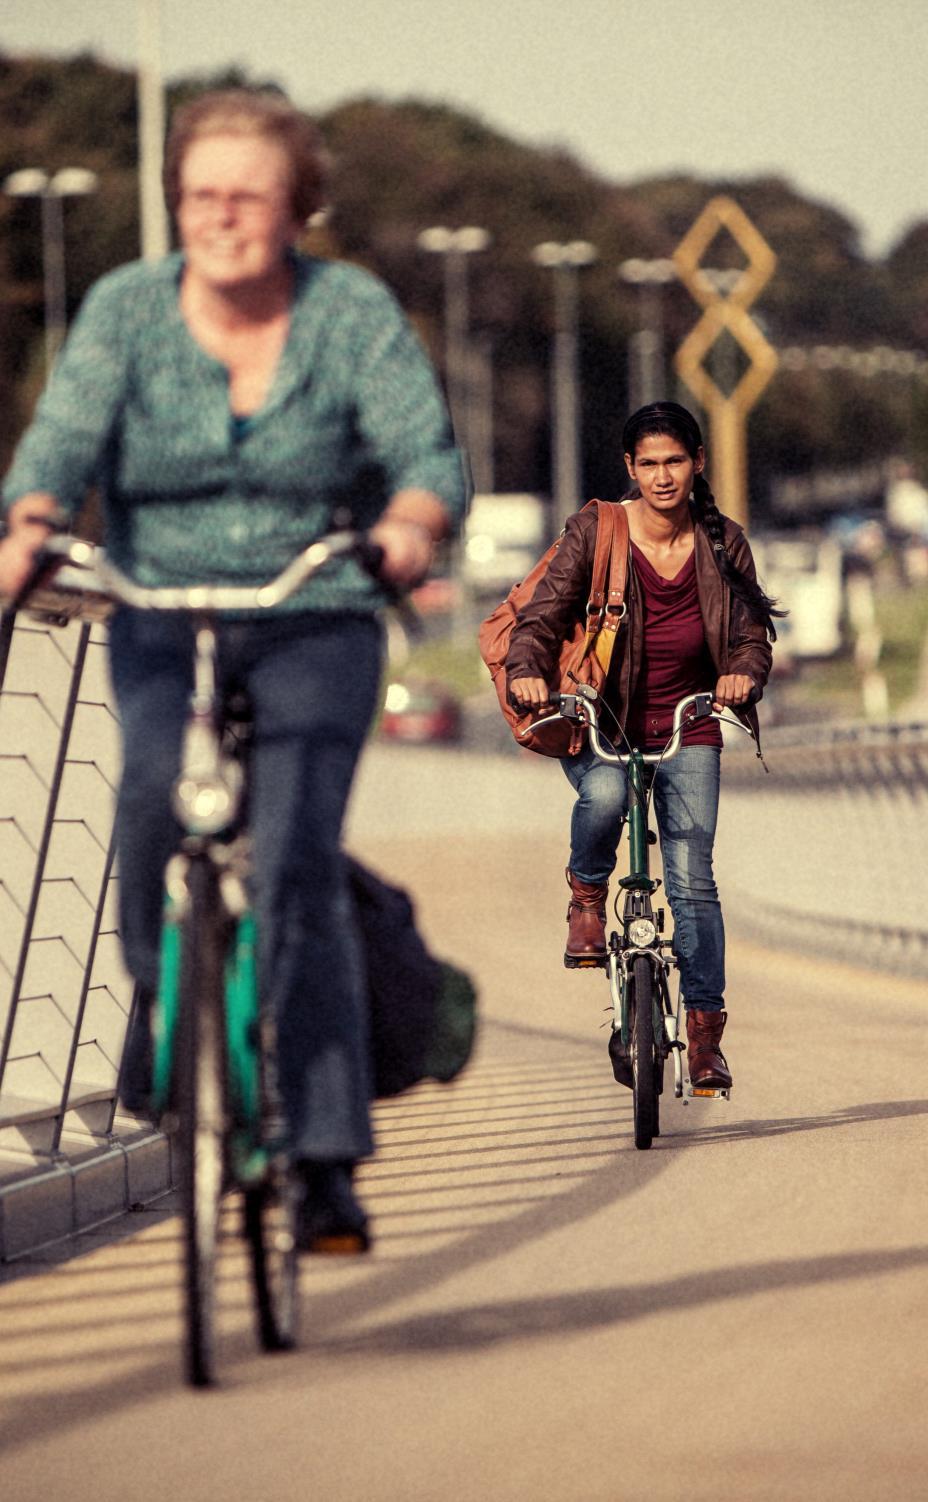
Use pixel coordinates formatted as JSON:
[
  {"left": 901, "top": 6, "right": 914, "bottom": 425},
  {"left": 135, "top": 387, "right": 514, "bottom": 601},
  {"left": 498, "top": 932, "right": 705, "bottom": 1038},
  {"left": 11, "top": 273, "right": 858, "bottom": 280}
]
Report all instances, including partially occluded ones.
[{"left": 562, "top": 746, "right": 725, "bottom": 1011}]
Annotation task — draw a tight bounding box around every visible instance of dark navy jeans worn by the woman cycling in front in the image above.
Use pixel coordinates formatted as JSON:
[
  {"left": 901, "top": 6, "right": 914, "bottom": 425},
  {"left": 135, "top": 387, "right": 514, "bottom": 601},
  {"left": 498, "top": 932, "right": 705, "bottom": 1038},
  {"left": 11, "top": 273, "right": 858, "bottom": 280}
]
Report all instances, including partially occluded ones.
[{"left": 110, "top": 610, "right": 381, "bottom": 1161}]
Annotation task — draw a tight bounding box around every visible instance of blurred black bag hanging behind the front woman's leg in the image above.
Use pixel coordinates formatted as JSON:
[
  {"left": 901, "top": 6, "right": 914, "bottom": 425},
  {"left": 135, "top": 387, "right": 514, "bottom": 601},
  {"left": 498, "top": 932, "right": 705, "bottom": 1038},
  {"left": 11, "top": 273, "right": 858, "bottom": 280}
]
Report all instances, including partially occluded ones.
[{"left": 345, "top": 856, "right": 476, "bottom": 1098}]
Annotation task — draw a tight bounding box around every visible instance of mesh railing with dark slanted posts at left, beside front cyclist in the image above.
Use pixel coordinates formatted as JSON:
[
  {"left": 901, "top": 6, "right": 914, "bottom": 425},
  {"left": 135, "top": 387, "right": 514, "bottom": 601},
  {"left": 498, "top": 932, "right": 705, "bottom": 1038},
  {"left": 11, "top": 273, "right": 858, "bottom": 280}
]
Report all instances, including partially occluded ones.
[{"left": 0, "top": 603, "right": 134, "bottom": 1172}]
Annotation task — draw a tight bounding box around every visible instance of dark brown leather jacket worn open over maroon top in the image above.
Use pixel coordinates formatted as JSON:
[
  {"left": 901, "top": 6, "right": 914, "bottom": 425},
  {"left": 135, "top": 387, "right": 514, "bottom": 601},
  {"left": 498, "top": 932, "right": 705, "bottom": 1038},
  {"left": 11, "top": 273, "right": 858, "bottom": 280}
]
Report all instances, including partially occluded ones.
[{"left": 506, "top": 502, "right": 773, "bottom": 745}]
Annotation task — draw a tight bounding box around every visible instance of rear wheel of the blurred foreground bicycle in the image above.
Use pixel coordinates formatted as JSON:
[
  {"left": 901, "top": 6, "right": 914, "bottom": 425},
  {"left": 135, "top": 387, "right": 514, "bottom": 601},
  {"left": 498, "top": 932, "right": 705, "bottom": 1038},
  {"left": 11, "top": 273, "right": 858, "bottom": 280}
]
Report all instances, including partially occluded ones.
[{"left": 245, "top": 1178, "right": 299, "bottom": 1350}]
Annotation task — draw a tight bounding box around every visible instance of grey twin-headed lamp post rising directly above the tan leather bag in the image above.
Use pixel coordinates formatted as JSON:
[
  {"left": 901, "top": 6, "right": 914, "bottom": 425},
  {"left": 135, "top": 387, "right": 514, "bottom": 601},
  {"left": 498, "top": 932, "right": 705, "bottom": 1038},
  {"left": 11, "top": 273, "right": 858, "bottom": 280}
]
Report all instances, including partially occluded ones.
[{"left": 532, "top": 240, "right": 596, "bottom": 532}]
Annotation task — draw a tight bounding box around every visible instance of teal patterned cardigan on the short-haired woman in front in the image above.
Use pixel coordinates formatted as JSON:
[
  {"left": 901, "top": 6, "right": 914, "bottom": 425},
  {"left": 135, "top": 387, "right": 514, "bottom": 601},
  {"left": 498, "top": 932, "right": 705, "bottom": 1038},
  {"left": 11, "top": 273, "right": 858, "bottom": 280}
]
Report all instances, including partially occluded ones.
[{"left": 3, "top": 254, "right": 466, "bottom": 611}]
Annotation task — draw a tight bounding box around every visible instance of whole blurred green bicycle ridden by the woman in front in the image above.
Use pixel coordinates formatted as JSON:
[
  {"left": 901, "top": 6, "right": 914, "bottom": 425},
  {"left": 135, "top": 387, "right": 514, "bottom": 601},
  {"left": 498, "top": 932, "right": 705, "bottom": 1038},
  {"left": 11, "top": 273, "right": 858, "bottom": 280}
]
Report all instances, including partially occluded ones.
[{"left": 21, "top": 532, "right": 381, "bottom": 1386}]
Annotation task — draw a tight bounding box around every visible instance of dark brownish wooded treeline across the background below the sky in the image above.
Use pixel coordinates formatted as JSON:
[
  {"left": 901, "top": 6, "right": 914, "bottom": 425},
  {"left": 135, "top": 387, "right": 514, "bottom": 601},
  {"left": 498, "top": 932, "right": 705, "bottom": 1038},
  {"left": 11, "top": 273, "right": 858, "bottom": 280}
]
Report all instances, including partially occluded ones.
[{"left": 0, "top": 56, "right": 928, "bottom": 514}]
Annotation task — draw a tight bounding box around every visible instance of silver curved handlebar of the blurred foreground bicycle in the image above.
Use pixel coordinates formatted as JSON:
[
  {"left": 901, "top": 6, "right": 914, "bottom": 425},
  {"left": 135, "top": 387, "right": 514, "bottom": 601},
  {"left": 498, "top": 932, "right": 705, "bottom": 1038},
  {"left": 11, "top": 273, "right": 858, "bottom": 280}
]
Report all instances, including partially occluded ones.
[{"left": 9, "top": 532, "right": 383, "bottom": 619}]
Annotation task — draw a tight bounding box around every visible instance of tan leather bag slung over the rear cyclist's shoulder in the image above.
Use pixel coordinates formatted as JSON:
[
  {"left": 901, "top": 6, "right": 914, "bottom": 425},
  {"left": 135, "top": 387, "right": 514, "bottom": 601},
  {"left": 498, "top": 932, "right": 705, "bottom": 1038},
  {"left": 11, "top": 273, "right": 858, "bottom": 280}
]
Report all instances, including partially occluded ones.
[{"left": 478, "top": 500, "right": 628, "bottom": 757}]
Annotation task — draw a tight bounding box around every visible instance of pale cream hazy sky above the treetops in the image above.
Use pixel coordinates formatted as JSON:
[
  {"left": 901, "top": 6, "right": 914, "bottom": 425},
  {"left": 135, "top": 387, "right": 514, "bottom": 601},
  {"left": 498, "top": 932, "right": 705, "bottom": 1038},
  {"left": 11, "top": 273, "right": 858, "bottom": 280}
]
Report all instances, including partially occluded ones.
[{"left": 0, "top": 0, "right": 928, "bottom": 255}]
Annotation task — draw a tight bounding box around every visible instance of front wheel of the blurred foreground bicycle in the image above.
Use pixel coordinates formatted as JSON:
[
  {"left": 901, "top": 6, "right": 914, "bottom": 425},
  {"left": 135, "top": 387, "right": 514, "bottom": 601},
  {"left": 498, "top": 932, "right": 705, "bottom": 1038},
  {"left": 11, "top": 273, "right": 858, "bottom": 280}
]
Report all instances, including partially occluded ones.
[{"left": 176, "top": 856, "right": 227, "bottom": 1386}]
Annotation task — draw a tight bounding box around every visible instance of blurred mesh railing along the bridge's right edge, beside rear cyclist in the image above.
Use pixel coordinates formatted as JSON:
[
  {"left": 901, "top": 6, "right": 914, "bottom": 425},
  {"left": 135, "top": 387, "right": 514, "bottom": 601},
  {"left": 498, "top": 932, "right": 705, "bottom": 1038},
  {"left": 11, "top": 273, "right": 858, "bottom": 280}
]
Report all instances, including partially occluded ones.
[{"left": 716, "top": 724, "right": 928, "bottom": 975}]
